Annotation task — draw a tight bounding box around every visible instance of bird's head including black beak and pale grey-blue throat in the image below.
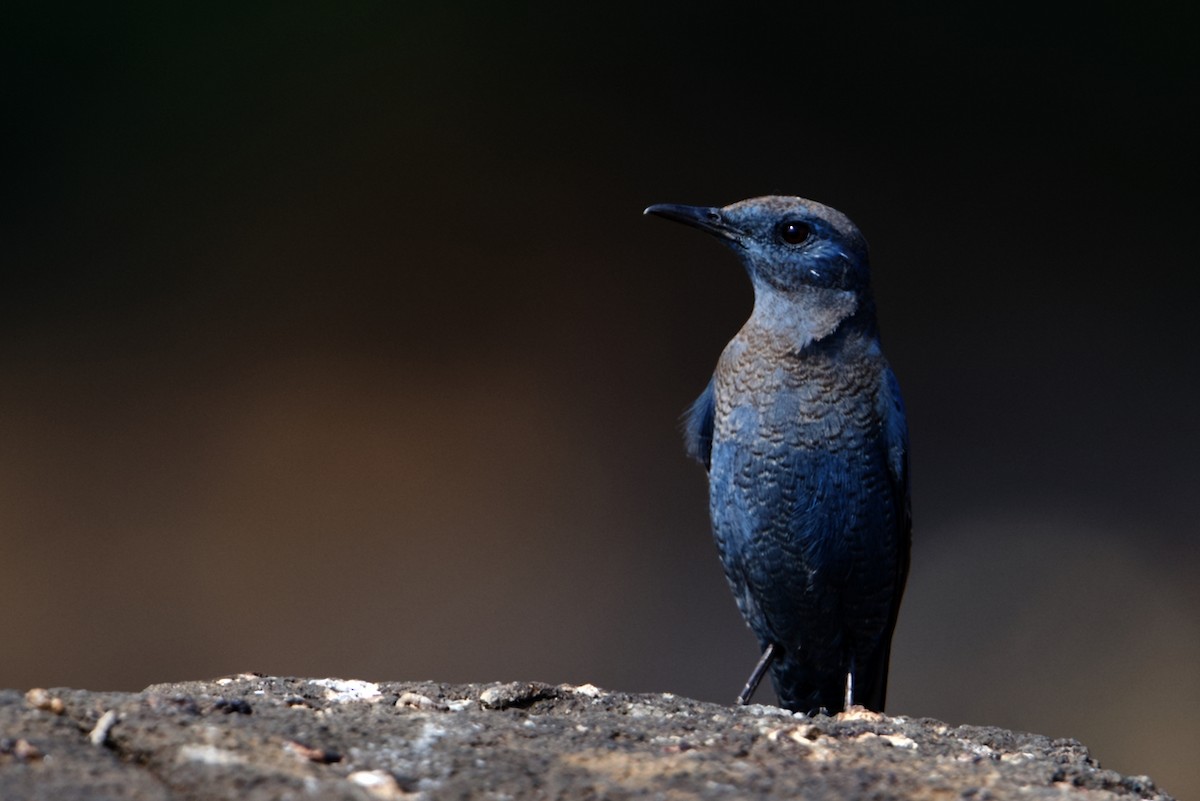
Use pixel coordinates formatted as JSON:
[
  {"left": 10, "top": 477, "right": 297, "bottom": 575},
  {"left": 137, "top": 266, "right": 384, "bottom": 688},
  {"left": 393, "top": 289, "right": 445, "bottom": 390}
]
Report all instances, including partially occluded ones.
[{"left": 646, "top": 195, "right": 875, "bottom": 344}]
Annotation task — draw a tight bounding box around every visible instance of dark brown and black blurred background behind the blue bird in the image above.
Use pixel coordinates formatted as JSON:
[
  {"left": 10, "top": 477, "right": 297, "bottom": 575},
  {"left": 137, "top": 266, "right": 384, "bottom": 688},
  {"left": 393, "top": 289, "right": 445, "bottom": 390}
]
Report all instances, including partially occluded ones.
[{"left": 0, "top": 2, "right": 1200, "bottom": 797}]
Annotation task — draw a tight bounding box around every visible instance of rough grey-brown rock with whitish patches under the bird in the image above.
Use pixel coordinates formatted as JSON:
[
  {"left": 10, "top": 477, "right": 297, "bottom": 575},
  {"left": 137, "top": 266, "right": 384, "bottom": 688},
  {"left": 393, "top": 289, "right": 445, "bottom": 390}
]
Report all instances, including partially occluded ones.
[{"left": 0, "top": 674, "right": 1169, "bottom": 801}]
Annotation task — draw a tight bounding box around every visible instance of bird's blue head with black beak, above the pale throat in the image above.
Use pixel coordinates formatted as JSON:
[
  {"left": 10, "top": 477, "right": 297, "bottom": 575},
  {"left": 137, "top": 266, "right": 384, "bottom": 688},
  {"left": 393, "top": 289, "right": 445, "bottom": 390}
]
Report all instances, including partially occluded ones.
[{"left": 646, "top": 195, "right": 870, "bottom": 294}]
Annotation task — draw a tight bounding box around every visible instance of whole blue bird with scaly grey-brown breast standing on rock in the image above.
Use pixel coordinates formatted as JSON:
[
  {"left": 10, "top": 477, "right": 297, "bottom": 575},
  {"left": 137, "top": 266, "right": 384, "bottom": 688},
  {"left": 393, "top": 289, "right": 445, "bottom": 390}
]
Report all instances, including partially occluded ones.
[{"left": 644, "top": 195, "right": 912, "bottom": 715}]
